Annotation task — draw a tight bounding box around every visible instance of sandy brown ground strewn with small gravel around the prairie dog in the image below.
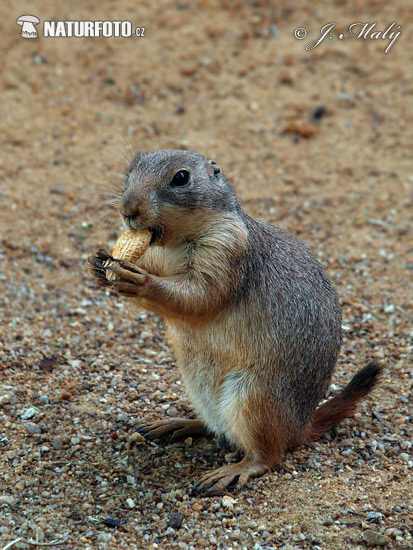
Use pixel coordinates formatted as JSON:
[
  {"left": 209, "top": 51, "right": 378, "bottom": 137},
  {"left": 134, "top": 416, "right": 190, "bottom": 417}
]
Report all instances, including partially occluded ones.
[{"left": 0, "top": 0, "right": 413, "bottom": 550}]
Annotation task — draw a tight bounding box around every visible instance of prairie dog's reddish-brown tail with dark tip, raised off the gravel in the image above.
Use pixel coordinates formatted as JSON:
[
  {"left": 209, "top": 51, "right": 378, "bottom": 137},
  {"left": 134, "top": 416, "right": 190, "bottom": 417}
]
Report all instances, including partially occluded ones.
[{"left": 292, "top": 362, "right": 383, "bottom": 448}]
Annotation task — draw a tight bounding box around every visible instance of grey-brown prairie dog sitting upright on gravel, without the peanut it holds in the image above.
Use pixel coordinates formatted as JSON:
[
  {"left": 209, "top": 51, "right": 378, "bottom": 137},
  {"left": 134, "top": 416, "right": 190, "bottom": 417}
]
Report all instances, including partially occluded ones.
[{"left": 89, "top": 149, "right": 381, "bottom": 494}]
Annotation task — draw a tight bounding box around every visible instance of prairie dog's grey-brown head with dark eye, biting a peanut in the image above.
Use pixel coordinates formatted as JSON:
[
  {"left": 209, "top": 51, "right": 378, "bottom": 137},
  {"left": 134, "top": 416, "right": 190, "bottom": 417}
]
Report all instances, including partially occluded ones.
[{"left": 119, "top": 149, "right": 238, "bottom": 240}]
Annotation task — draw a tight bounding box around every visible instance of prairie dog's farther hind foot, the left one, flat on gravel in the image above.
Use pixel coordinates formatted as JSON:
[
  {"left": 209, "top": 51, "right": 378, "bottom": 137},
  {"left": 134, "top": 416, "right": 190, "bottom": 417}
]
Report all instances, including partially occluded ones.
[{"left": 137, "top": 418, "right": 208, "bottom": 442}]
